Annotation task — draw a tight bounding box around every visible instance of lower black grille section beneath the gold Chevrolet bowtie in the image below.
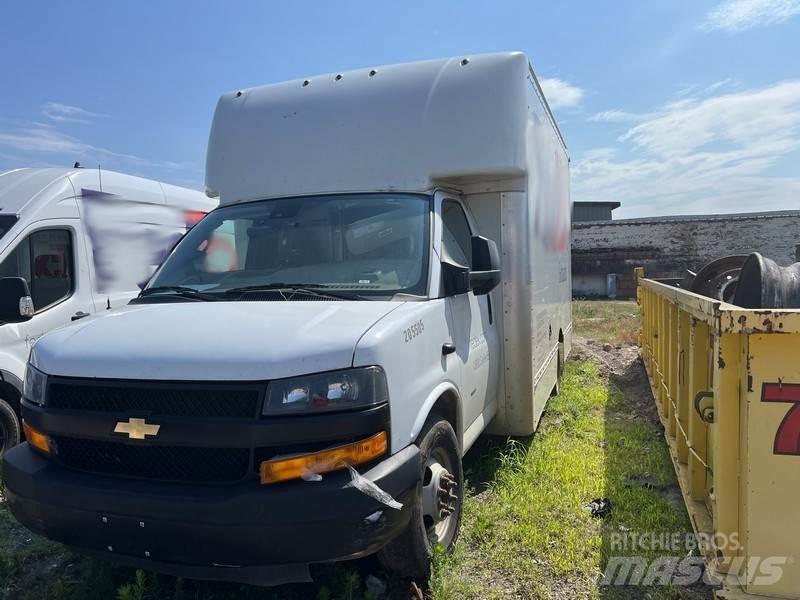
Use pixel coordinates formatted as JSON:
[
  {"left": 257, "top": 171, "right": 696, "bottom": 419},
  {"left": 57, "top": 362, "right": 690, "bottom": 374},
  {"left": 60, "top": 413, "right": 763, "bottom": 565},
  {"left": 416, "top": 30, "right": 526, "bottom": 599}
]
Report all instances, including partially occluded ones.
[{"left": 52, "top": 436, "right": 250, "bottom": 483}]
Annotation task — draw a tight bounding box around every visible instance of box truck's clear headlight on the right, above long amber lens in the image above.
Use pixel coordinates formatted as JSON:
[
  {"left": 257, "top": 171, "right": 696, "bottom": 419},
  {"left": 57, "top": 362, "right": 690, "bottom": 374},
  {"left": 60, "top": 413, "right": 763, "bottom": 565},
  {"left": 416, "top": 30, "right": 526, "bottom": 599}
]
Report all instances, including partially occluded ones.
[{"left": 262, "top": 367, "right": 389, "bottom": 415}]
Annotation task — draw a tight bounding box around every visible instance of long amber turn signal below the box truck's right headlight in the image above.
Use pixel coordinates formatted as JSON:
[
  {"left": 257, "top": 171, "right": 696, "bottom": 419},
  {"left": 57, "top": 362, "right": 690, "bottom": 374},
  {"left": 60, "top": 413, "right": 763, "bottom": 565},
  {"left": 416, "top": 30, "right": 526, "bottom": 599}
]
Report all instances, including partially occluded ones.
[{"left": 260, "top": 431, "right": 389, "bottom": 484}]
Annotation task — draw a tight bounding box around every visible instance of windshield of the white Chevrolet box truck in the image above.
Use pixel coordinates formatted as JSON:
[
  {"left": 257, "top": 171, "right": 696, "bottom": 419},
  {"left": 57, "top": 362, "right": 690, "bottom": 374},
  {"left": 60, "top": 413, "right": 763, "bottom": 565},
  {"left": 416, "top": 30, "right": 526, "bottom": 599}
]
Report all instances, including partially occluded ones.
[{"left": 148, "top": 194, "right": 430, "bottom": 296}]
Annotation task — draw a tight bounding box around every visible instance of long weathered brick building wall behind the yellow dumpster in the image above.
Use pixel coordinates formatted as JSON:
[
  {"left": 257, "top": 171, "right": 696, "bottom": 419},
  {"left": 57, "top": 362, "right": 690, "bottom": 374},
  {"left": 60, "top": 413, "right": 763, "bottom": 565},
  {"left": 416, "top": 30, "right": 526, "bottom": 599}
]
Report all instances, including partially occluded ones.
[{"left": 572, "top": 211, "right": 800, "bottom": 297}]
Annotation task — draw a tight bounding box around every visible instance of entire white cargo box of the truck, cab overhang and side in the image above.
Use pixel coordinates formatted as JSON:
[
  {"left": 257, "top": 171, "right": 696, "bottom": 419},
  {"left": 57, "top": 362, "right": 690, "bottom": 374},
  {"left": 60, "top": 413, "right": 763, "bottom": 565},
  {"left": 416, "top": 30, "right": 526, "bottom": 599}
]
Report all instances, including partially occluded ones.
[{"left": 206, "top": 53, "right": 572, "bottom": 435}]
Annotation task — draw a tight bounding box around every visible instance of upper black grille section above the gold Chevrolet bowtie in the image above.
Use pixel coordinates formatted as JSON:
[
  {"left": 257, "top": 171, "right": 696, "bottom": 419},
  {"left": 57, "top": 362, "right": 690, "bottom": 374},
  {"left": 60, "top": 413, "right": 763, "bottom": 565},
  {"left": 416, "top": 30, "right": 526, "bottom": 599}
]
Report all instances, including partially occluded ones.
[{"left": 47, "top": 380, "right": 263, "bottom": 419}]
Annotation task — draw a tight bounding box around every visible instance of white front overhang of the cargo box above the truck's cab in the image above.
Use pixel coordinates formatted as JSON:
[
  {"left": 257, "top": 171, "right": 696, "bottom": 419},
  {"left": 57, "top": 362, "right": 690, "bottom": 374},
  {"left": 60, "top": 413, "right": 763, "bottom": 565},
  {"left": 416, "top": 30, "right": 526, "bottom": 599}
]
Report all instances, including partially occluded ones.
[{"left": 206, "top": 54, "right": 549, "bottom": 203}]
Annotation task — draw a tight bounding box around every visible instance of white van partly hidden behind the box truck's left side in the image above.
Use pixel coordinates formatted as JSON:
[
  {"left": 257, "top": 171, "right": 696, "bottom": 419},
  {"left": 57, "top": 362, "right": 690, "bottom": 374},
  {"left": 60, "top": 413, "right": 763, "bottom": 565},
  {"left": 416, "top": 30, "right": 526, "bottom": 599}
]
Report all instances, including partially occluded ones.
[{"left": 0, "top": 168, "right": 216, "bottom": 454}]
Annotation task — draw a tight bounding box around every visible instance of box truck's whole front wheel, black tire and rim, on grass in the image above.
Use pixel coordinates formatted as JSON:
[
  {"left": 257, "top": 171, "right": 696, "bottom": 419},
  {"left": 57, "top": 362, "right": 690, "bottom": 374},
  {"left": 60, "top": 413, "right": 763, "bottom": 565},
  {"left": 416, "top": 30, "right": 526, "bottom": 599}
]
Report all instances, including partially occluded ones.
[{"left": 378, "top": 415, "right": 464, "bottom": 579}]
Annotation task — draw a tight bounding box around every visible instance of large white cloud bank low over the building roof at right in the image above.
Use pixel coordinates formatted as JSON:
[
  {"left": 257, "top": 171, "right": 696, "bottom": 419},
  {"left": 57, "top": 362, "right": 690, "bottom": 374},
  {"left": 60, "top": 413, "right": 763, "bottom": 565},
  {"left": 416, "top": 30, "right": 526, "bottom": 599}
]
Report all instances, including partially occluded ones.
[{"left": 573, "top": 80, "right": 800, "bottom": 217}]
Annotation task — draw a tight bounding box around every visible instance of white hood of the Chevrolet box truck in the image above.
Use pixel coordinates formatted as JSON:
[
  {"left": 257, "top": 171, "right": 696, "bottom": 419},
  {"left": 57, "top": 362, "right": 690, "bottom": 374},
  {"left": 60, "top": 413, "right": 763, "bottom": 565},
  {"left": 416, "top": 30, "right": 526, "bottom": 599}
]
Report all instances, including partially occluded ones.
[{"left": 31, "top": 301, "right": 403, "bottom": 381}]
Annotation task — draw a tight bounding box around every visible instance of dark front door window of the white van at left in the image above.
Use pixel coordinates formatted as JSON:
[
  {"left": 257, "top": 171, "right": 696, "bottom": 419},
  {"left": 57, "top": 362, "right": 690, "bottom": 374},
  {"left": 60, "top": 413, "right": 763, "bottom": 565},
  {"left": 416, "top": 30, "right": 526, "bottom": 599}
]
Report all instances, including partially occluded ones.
[{"left": 0, "top": 229, "right": 74, "bottom": 311}]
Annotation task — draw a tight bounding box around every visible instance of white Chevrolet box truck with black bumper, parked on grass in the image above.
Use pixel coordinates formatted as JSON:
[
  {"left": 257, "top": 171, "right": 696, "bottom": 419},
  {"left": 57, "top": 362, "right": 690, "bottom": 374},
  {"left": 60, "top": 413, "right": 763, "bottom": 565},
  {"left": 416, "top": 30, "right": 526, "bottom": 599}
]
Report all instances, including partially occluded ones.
[{"left": 3, "top": 53, "right": 572, "bottom": 584}]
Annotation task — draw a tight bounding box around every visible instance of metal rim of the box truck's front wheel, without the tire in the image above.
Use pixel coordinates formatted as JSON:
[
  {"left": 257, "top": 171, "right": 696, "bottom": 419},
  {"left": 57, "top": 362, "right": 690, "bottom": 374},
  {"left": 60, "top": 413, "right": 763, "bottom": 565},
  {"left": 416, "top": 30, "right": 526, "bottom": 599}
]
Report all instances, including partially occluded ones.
[{"left": 422, "top": 448, "right": 460, "bottom": 545}]
